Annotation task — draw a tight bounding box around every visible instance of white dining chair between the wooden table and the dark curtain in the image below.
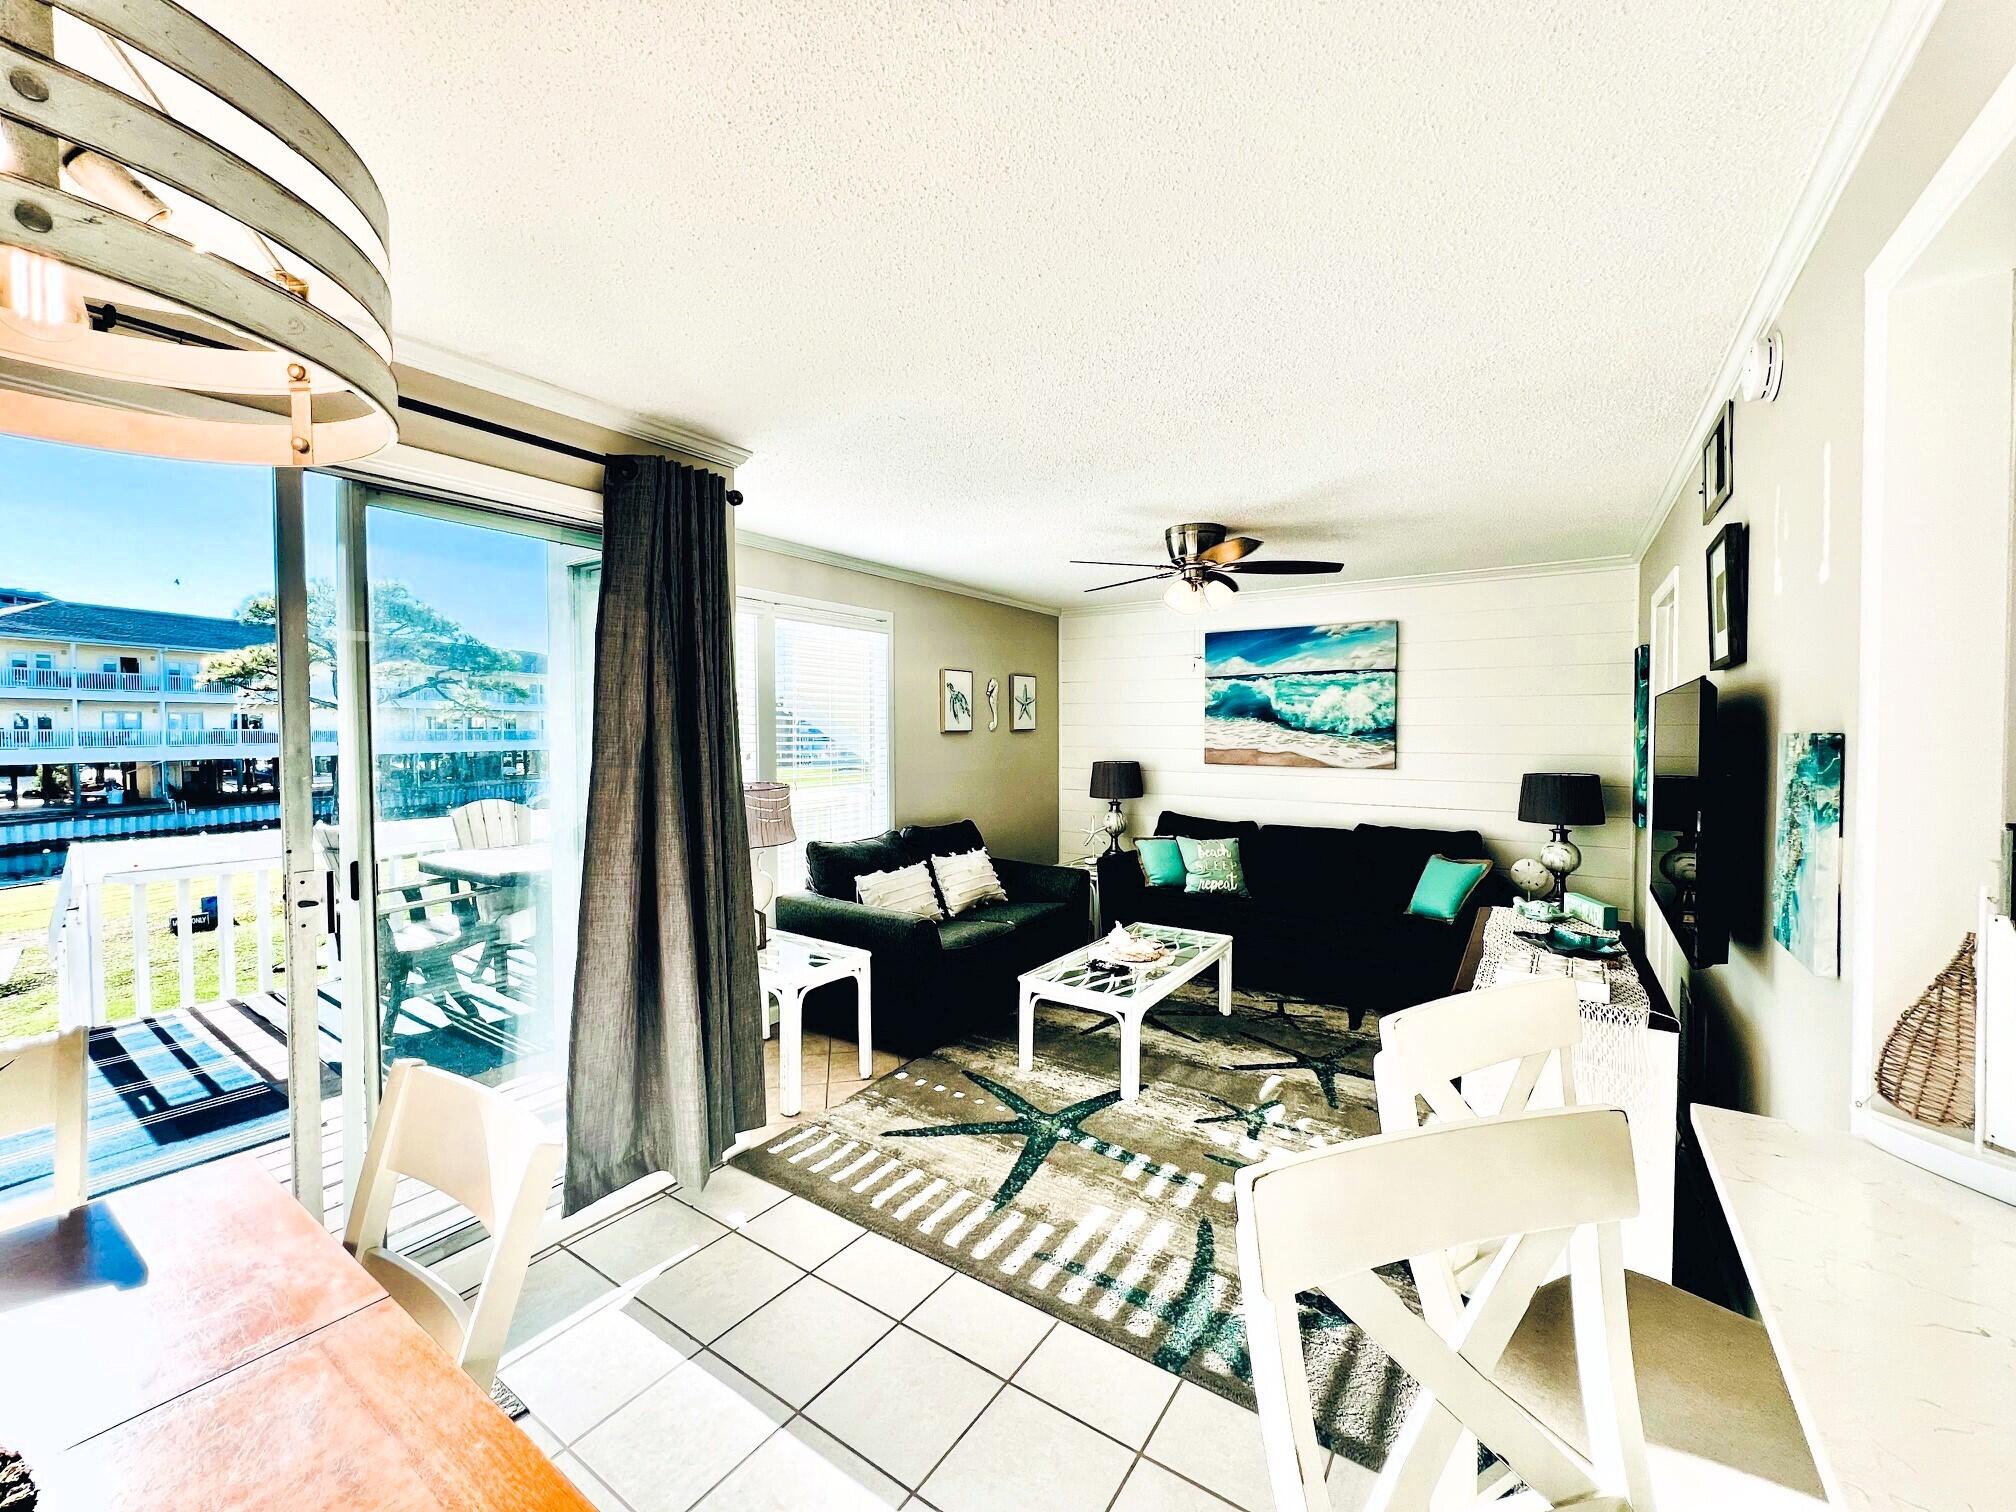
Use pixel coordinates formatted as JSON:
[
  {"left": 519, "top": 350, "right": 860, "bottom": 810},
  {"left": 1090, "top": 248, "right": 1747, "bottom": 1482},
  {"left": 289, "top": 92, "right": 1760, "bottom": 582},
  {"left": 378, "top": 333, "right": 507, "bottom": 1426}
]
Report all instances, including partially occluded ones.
[{"left": 343, "top": 1060, "right": 560, "bottom": 1391}]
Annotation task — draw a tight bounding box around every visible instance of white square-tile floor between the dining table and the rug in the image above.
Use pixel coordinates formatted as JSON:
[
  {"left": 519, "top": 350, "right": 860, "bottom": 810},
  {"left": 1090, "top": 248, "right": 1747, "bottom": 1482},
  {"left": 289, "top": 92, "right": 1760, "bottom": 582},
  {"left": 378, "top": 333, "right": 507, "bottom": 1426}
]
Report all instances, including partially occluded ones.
[{"left": 464, "top": 1036, "right": 1371, "bottom": 1512}]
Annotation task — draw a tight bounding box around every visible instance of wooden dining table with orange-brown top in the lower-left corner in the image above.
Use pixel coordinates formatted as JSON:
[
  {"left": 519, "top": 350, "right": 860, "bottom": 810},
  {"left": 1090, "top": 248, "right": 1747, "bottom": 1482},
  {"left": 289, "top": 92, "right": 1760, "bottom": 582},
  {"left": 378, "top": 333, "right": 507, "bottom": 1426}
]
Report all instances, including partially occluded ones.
[{"left": 0, "top": 1155, "right": 593, "bottom": 1512}]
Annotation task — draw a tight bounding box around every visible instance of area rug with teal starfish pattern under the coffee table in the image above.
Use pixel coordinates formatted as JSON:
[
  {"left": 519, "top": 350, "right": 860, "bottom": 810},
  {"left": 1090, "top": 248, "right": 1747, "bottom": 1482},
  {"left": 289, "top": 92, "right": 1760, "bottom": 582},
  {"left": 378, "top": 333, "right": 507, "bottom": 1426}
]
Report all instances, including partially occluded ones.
[{"left": 732, "top": 982, "right": 1413, "bottom": 1468}]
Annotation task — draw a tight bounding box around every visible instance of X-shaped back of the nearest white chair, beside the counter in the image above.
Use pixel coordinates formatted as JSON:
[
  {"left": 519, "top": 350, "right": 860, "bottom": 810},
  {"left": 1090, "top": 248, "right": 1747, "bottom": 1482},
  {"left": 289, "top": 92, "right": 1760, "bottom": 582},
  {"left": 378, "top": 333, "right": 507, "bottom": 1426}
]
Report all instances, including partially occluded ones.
[{"left": 1236, "top": 1109, "right": 1645, "bottom": 1512}]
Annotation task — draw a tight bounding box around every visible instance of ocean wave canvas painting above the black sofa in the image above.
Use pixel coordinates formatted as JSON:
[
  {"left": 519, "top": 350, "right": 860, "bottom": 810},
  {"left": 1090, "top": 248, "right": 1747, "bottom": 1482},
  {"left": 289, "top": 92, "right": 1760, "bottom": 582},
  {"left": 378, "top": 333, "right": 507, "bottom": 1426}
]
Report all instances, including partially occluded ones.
[{"left": 1204, "top": 619, "right": 1399, "bottom": 770}]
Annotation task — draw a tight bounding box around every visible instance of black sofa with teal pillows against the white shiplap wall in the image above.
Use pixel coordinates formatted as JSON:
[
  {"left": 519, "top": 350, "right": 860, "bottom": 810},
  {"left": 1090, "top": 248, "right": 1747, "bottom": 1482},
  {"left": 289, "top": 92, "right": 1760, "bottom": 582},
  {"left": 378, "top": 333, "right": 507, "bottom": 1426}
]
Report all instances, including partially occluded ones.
[{"left": 1099, "top": 812, "right": 1514, "bottom": 1028}]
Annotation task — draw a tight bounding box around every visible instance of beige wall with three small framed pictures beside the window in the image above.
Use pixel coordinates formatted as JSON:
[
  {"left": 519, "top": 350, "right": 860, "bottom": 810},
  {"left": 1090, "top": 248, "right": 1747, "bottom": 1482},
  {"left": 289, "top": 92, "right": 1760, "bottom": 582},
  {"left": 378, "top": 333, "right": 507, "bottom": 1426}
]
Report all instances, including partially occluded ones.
[{"left": 736, "top": 546, "right": 1058, "bottom": 861}]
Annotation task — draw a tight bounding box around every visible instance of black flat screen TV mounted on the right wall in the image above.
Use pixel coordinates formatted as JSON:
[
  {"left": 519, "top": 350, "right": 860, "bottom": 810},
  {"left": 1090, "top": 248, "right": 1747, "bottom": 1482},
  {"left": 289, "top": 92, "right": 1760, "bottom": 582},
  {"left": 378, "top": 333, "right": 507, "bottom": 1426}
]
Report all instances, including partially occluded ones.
[{"left": 1647, "top": 677, "right": 1730, "bottom": 966}]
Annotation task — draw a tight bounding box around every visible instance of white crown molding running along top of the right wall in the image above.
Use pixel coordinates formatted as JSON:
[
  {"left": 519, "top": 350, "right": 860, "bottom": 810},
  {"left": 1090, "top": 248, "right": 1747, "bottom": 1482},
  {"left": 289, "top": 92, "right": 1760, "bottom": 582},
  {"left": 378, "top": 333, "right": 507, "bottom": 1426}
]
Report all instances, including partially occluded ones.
[{"left": 1633, "top": 0, "right": 1945, "bottom": 556}]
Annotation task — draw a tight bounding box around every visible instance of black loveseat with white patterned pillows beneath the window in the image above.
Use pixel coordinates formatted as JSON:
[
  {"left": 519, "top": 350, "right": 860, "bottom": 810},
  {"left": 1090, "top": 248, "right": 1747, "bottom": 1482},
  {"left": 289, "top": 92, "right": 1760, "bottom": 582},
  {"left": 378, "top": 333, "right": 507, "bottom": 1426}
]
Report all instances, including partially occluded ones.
[{"left": 776, "top": 818, "right": 1093, "bottom": 1056}]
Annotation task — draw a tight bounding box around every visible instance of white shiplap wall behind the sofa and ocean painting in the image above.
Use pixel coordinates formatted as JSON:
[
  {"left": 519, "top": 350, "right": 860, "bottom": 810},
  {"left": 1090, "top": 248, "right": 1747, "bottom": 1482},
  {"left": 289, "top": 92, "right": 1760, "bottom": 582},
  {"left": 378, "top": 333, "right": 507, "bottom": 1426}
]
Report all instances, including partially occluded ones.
[{"left": 1056, "top": 564, "right": 1637, "bottom": 915}]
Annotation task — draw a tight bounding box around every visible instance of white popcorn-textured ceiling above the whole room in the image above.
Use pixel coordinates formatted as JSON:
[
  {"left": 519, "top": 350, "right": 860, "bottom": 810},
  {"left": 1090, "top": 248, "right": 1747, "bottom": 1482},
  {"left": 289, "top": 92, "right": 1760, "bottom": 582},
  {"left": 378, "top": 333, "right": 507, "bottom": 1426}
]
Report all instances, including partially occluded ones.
[{"left": 194, "top": 0, "right": 1883, "bottom": 603}]
